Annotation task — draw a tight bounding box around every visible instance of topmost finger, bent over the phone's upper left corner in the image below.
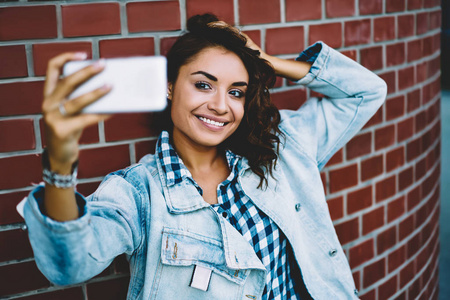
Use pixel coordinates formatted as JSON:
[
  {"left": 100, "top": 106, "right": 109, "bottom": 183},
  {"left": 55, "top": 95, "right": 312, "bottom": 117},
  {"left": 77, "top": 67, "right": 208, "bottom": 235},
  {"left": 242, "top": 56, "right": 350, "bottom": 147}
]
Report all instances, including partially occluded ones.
[{"left": 44, "top": 52, "right": 87, "bottom": 97}]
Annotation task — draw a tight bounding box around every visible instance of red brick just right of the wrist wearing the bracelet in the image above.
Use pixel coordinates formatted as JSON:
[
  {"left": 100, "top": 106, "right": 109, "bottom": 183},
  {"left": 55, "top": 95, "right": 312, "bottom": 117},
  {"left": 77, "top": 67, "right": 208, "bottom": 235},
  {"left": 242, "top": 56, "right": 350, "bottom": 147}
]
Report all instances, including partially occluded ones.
[{"left": 78, "top": 145, "right": 130, "bottom": 178}]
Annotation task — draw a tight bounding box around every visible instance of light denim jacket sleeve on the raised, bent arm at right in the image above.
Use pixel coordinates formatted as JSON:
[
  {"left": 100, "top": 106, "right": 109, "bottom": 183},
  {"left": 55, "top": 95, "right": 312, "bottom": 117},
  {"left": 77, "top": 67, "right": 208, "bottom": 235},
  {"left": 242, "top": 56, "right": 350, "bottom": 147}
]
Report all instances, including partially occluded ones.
[{"left": 280, "top": 42, "right": 387, "bottom": 169}]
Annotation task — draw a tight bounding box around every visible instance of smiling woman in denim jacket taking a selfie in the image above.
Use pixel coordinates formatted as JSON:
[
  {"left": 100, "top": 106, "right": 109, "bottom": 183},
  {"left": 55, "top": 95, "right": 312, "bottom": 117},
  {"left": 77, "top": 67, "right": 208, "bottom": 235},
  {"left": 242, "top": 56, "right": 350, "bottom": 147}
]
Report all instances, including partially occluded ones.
[{"left": 25, "top": 15, "right": 386, "bottom": 299}]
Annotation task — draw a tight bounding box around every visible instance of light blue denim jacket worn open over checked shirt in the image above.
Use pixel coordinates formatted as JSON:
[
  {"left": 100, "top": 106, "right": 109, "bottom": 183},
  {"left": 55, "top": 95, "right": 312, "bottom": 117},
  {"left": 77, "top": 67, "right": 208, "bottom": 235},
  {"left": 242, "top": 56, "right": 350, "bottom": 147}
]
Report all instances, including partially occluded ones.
[{"left": 24, "top": 43, "right": 386, "bottom": 299}]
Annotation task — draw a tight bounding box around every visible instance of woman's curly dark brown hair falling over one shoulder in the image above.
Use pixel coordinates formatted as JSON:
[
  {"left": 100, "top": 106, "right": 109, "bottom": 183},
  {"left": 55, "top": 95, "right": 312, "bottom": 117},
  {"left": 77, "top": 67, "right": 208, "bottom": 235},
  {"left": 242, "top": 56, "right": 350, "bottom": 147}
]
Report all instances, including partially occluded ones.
[{"left": 165, "top": 14, "right": 282, "bottom": 188}]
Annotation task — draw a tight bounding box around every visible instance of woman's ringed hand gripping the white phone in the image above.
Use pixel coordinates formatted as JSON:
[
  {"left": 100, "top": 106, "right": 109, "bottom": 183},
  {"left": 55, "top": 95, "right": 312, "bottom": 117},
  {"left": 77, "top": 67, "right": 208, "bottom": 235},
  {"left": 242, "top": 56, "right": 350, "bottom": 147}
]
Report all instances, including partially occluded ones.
[{"left": 42, "top": 53, "right": 111, "bottom": 174}]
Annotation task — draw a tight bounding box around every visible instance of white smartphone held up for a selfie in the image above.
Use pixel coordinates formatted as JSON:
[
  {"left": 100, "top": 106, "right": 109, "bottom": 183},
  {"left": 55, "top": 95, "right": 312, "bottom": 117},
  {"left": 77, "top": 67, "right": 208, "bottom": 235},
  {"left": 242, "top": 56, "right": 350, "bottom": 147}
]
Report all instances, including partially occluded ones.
[{"left": 63, "top": 56, "right": 167, "bottom": 113}]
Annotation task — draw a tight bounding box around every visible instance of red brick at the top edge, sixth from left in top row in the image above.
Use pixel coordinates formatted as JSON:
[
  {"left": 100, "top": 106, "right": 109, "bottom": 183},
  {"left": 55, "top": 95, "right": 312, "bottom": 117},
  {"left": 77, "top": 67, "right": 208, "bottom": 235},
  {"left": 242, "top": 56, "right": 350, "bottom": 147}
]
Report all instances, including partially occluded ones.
[{"left": 286, "top": 0, "right": 322, "bottom": 22}]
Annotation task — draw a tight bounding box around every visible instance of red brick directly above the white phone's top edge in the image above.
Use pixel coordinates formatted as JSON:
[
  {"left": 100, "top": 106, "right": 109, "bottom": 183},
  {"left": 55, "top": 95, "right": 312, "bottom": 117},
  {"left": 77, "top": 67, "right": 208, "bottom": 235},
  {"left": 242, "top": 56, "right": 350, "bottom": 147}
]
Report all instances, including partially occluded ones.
[{"left": 99, "top": 37, "right": 155, "bottom": 58}]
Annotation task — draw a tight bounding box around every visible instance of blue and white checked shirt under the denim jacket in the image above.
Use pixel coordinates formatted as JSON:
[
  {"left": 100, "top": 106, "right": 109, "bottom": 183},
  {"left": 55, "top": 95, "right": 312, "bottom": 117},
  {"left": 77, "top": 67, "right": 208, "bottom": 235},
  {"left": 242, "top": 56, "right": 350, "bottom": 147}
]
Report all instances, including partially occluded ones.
[{"left": 156, "top": 131, "right": 300, "bottom": 299}]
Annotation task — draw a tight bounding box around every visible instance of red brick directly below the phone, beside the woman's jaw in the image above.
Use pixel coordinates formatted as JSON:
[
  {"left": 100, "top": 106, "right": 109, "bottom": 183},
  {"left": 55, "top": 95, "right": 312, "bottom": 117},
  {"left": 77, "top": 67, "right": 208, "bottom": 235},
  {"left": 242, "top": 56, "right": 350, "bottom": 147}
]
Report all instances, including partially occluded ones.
[{"left": 105, "top": 113, "right": 157, "bottom": 142}]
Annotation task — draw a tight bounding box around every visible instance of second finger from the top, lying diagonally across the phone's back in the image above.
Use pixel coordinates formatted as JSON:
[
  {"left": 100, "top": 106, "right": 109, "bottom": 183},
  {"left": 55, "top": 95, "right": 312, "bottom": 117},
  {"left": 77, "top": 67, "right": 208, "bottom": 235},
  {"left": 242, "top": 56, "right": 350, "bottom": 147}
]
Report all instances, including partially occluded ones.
[{"left": 52, "top": 59, "right": 105, "bottom": 102}]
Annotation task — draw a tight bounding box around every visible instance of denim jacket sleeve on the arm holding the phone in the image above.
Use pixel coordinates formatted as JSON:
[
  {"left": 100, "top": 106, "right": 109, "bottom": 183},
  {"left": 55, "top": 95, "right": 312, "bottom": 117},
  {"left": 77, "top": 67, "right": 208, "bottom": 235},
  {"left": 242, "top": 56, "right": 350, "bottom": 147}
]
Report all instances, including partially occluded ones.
[{"left": 24, "top": 168, "right": 143, "bottom": 285}]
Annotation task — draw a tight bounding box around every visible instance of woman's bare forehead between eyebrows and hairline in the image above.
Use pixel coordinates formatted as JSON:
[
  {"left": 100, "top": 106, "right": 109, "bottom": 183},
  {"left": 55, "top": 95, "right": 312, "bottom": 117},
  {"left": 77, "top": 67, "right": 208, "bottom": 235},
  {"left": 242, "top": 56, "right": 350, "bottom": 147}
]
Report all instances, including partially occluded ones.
[{"left": 180, "top": 47, "right": 249, "bottom": 82}]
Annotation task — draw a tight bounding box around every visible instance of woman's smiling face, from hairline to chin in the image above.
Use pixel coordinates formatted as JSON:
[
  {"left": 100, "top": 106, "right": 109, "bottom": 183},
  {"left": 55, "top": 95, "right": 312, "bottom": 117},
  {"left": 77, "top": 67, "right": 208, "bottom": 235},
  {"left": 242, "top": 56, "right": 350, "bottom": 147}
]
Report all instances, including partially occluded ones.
[{"left": 169, "top": 47, "right": 249, "bottom": 147}]
